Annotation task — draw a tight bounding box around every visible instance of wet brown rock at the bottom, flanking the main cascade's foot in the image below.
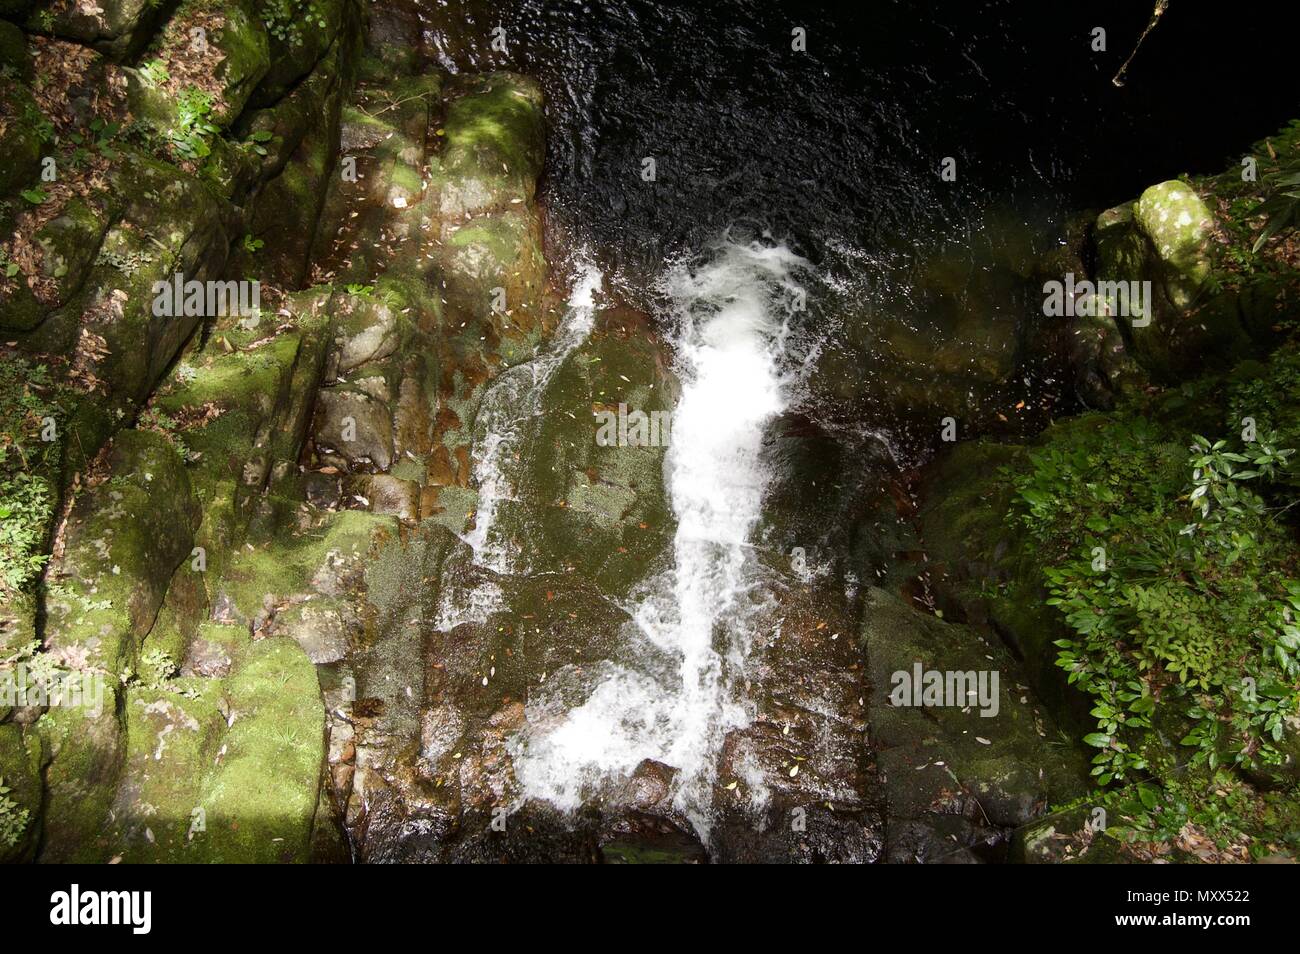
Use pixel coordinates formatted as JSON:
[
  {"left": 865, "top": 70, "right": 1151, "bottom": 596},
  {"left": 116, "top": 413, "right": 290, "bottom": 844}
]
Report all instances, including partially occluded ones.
[{"left": 345, "top": 522, "right": 881, "bottom": 863}]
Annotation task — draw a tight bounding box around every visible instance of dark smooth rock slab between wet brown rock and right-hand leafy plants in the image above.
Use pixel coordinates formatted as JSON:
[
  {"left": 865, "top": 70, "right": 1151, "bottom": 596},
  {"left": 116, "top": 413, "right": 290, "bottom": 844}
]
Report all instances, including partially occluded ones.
[{"left": 859, "top": 589, "right": 1087, "bottom": 863}]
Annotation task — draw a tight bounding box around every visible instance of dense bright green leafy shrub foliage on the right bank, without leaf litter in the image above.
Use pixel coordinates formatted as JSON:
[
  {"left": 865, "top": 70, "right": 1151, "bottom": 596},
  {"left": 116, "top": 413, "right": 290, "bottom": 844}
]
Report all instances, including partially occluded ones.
[{"left": 1013, "top": 415, "right": 1300, "bottom": 785}]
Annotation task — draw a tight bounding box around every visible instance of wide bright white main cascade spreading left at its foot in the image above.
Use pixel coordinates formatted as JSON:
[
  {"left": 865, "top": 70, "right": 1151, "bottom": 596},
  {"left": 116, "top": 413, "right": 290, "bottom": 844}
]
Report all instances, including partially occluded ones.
[{"left": 516, "top": 243, "right": 806, "bottom": 834}]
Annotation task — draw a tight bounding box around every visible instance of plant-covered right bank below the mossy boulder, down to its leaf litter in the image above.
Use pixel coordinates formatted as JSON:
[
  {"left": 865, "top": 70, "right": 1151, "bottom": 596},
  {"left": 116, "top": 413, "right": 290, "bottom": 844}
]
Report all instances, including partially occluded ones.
[{"left": 1004, "top": 342, "right": 1300, "bottom": 847}]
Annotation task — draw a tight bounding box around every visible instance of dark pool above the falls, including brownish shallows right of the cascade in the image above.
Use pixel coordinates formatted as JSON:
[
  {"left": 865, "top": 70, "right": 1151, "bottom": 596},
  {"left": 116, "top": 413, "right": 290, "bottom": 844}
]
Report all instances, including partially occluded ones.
[{"left": 421, "top": 0, "right": 1300, "bottom": 459}]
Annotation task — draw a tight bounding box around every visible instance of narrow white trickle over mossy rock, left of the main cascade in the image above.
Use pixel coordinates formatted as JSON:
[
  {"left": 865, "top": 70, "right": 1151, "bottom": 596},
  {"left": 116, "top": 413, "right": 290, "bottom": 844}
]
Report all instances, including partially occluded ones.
[{"left": 463, "top": 261, "right": 602, "bottom": 573}]
